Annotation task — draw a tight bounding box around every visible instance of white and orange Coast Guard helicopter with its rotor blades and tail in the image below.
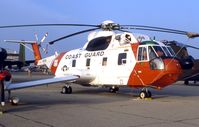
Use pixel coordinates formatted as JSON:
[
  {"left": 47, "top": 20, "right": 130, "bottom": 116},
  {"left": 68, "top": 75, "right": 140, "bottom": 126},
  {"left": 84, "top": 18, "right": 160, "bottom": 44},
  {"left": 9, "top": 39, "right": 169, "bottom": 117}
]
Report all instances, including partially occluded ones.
[{"left": 0, "top": 20, "right": 199, "bottom": 103}]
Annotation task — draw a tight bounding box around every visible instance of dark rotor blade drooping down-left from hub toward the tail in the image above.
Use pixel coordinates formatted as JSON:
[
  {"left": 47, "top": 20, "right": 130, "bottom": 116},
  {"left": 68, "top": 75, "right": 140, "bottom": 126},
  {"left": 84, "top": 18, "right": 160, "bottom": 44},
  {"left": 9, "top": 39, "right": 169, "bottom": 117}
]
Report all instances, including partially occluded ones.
[{"left": 48, "top": 28, "right": 100, "bottom": 45}]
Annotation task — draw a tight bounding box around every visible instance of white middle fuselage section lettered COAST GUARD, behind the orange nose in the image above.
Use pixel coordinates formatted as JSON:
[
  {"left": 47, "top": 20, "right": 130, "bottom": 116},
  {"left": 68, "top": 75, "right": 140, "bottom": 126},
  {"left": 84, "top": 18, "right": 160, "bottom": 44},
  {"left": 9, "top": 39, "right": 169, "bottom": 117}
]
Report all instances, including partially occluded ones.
[{"left": 49, "top": 31, "right": 141, "bottom": 85}]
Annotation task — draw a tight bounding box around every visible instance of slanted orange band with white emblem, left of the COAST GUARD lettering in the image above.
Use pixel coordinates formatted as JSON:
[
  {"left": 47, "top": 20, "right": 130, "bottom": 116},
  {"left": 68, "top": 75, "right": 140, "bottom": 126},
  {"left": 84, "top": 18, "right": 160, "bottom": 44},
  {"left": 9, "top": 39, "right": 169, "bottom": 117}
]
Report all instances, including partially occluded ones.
[{"left": 51, "top": 52, "right": 66, "bottom": 74}]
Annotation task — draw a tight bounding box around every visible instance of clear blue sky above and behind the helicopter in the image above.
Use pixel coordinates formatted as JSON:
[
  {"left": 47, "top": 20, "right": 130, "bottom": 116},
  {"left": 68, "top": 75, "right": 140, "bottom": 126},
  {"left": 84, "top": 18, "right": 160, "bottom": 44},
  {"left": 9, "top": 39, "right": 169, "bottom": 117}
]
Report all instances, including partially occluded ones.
[{"left": 0, "top": 0, "right": 199, "bottom": 59}]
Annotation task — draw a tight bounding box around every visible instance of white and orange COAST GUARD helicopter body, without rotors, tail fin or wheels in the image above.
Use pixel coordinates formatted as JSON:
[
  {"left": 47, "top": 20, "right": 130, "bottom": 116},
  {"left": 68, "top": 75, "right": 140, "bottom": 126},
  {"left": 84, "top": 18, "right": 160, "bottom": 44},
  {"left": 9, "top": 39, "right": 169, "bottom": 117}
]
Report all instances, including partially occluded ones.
[{"left": 39, "top": 31, "right": 181, "bottom": 89}]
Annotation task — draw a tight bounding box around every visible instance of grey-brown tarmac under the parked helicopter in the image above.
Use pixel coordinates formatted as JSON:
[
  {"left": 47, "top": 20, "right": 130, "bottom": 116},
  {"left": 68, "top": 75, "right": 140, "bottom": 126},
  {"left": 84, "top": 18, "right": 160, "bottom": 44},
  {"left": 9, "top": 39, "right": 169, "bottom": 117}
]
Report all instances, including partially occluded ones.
[{"left": 0, "top": 73, "right": 199, "bottom": 127}]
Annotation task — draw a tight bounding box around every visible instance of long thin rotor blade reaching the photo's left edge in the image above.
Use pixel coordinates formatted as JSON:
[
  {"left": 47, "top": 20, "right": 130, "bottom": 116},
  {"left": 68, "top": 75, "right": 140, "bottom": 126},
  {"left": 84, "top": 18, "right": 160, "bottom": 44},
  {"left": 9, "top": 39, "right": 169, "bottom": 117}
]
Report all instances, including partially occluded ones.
[{"left": 0, "top": 24, "right": 100, "bottom": 28}]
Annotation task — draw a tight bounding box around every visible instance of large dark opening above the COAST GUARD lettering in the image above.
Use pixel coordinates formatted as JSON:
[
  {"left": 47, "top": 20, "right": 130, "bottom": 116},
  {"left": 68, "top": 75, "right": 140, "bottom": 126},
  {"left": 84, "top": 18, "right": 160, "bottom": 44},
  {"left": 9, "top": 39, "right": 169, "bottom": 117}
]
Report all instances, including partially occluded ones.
[{"left": 86, "top": 36, "right": 112, "bottom": 51}]
